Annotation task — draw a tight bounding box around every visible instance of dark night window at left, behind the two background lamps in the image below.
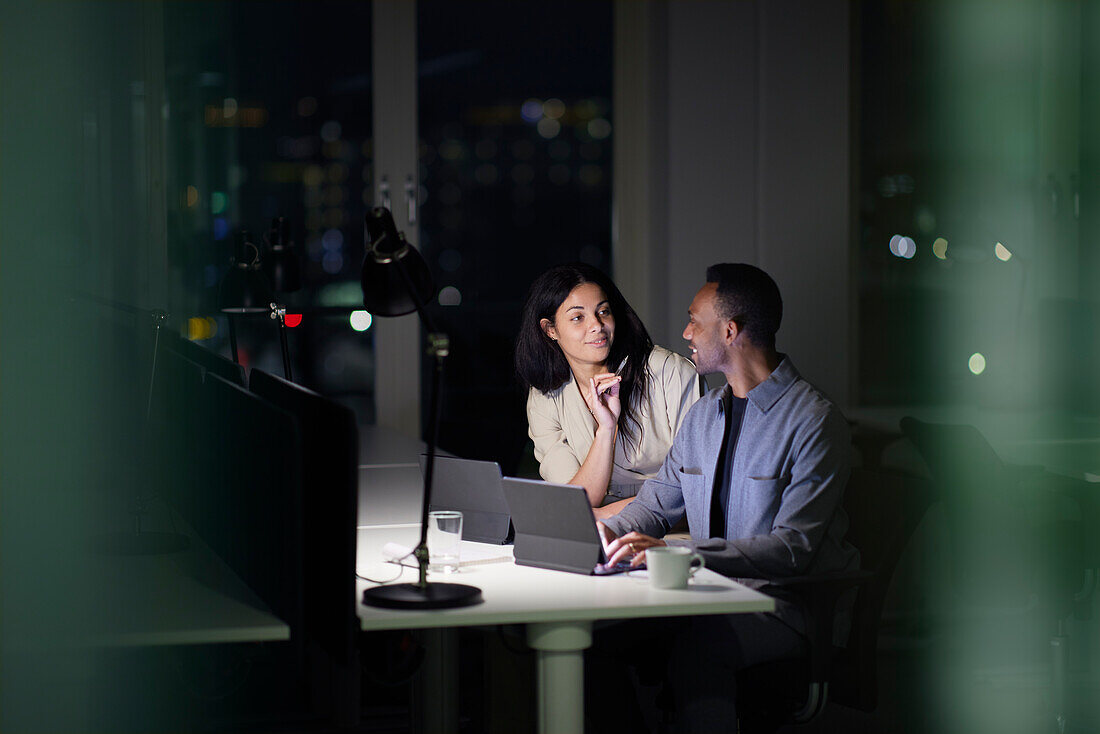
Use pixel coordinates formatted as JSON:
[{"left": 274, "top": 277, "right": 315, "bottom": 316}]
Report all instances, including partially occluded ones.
[{"left": 165, "top": 2, "right": 374, "bottom": 423}]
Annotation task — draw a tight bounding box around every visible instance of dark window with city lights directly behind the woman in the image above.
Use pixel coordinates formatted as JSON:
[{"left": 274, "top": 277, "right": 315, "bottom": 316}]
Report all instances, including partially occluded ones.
[{"left": 417, "top": 0, "right": 614, "bottom": 471}]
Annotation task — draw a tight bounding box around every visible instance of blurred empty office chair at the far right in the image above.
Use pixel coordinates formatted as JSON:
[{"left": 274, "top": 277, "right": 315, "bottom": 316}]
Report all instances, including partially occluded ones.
[{"left": 901, "top": 417, "right": 1098, "bottom": 731}]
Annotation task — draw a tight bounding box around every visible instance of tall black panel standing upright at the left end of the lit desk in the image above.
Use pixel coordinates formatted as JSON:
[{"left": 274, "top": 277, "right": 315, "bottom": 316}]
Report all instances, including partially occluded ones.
[{"left": 249, "top": 369, "right": 359, "bottom": 662}]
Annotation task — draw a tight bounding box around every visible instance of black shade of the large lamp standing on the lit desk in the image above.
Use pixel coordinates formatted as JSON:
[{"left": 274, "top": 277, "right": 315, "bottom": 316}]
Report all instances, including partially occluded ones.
[{"left": 360, "top": 207, "right": 436, "bottom": 316}]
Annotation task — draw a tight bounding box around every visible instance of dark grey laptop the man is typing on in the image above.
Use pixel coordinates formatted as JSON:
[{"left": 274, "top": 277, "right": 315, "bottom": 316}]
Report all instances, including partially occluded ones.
[{"left": 501, "top": 476, "right": 636, "bottom": 576}]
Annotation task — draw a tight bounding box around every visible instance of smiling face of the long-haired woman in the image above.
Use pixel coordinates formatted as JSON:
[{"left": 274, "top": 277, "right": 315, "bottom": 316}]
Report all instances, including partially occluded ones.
[{"left": 541, "top": 283, "right": 615, "bottom": 364}]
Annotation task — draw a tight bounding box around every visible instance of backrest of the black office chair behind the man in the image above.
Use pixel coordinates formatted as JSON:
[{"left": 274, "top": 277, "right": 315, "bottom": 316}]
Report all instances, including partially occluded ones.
[{"left": 829, "top": 468, "right": 935, "bottom": 711}]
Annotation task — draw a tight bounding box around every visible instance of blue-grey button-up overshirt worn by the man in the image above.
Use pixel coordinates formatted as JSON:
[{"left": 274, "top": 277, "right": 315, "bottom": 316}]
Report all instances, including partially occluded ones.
[{"left": 606, "top": 357, "right": 859, "bottom": 579}]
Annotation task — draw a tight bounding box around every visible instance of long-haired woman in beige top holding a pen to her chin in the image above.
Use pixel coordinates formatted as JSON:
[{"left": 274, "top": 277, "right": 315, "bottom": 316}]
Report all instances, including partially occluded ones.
[{"left": 516, "top": 264, "right": 700, "bottom": 517}]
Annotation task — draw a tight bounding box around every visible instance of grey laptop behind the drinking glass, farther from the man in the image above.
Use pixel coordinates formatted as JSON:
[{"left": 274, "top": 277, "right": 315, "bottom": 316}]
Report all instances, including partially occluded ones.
[{"left": 420, "top": 453, "right": 512, "bottom": 545}]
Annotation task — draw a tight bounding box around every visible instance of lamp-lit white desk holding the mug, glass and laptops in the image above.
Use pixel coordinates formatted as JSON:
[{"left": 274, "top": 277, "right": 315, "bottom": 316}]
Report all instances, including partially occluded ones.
[{"left": 356, "top": 525, "right": 774, "bottom": 734}]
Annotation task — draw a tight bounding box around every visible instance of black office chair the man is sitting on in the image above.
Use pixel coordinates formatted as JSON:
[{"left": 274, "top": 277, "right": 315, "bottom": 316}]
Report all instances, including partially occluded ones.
[{"left": 737, "top": 468, "right": 935, "bottom": 733}]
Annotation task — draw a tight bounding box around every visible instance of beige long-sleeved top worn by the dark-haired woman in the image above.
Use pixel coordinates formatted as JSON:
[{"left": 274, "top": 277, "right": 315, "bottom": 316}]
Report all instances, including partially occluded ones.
[{"left": 527, "top": 347, "right": 701, "bottom": 502}]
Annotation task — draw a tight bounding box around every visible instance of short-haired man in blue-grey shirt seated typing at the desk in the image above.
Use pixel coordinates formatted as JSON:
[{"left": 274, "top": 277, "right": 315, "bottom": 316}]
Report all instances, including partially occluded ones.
[{"left": 602, "top": 264, "right": 859, "bottom": 731}]
